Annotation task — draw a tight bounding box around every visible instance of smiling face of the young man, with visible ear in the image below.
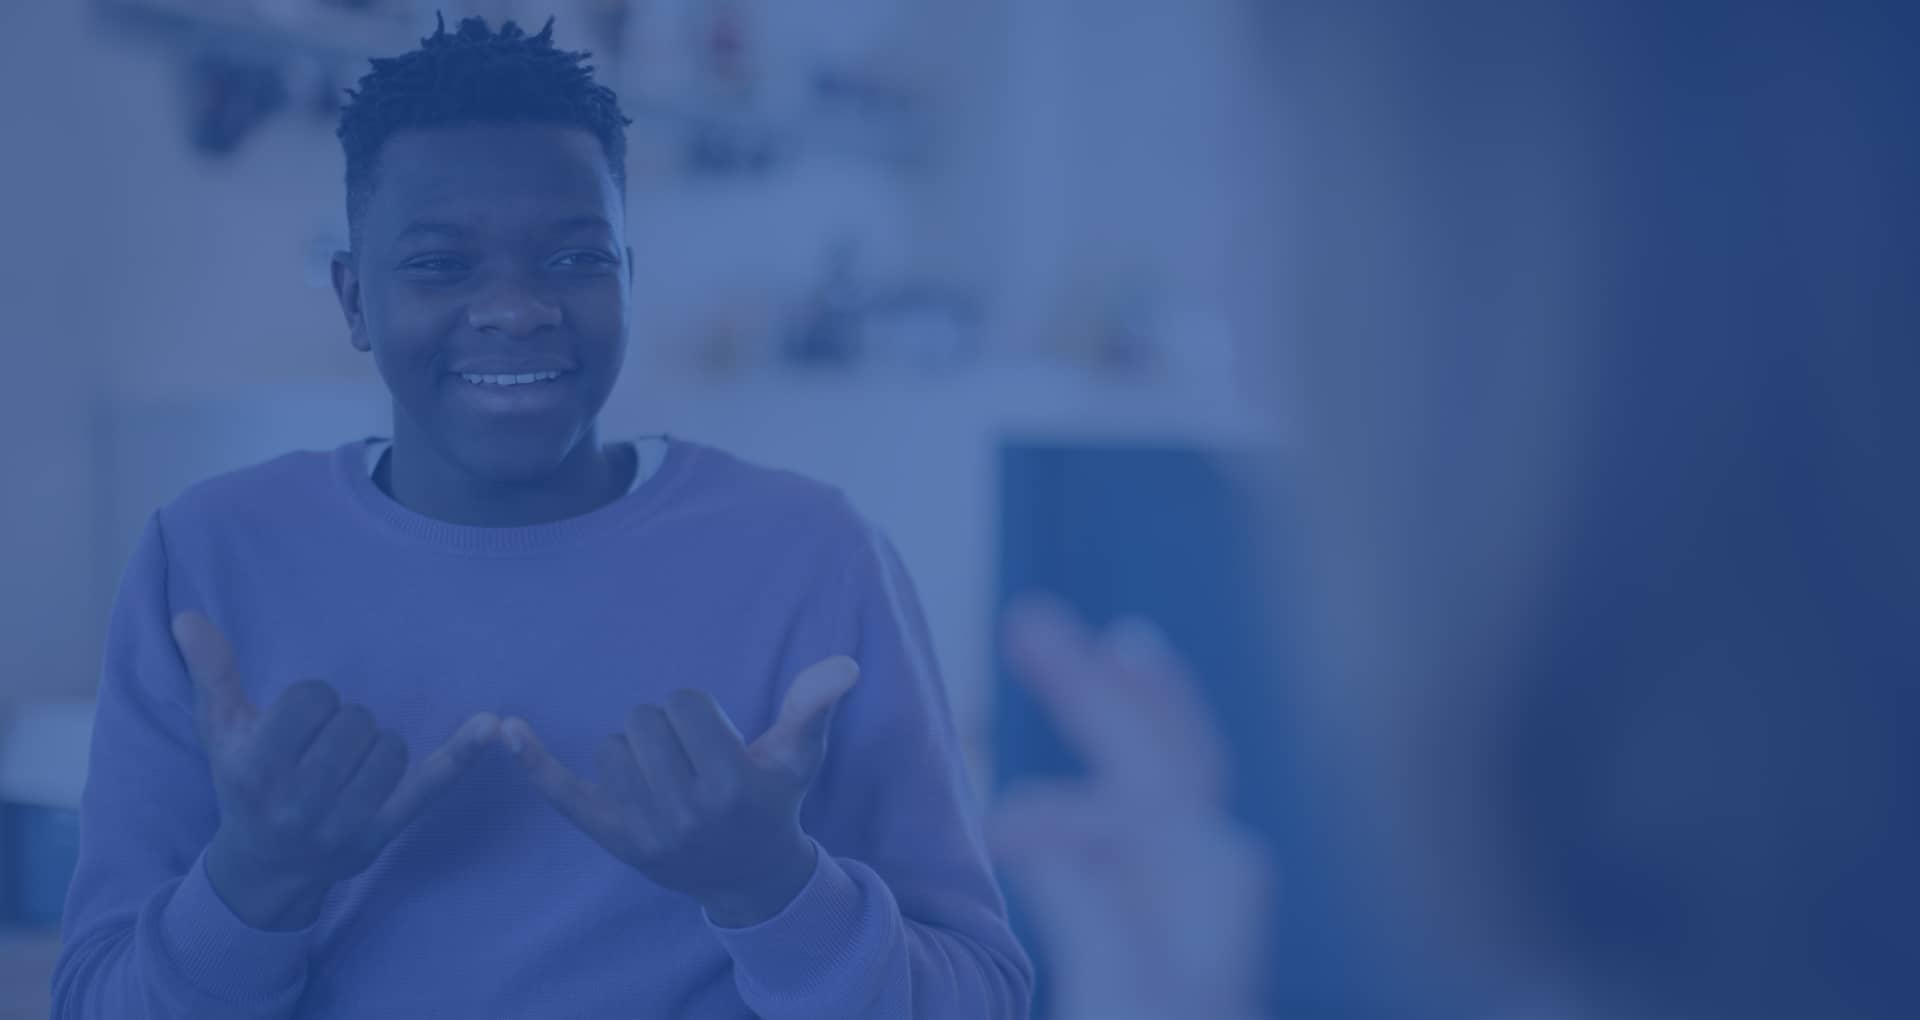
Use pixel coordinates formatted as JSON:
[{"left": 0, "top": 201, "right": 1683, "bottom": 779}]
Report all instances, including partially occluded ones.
[{"left": 334, "top": 125, "right": 632, "bottom": 482}]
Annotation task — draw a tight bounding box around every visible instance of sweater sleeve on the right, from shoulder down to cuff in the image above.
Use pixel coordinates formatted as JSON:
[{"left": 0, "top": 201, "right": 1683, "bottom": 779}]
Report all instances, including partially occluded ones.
[{"left": 714, "top": 528, "right": 1033, "bottom": 1020}]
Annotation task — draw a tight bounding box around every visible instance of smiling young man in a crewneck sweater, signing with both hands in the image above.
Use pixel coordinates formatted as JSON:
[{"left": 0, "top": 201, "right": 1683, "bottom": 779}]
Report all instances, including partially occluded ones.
[{"left": 54, "top": 19, "right": 1031, "bottom": 1020}]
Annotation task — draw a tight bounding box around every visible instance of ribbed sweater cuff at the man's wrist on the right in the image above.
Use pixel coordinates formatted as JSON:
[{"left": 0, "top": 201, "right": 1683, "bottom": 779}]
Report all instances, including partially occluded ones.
[{"left": 707, "top": 843, "right": 893, "bottom": 999}]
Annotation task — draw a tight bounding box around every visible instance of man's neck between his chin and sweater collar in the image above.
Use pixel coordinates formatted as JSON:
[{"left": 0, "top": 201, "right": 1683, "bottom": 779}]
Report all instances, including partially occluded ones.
[{"left": 374, "top": 430, "right": 634, "bottom": 528}]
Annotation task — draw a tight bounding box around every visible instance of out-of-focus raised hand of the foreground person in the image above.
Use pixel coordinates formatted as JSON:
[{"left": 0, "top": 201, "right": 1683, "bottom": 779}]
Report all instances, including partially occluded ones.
[{"left": 991, "top": 599, "right": 1269, "bottom": 1020}]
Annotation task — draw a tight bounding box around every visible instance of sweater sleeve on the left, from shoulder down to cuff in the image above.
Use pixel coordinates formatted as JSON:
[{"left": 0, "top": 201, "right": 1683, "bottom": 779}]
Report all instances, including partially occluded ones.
[{"left": 52, "top": 515, "right": 307, "bottom": 1020}]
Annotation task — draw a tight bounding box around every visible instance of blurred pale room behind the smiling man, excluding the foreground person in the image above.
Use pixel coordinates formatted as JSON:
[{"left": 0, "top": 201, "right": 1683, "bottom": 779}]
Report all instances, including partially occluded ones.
[{"left": 0, "top": 0, "right": 1290, "bottom": 1016}]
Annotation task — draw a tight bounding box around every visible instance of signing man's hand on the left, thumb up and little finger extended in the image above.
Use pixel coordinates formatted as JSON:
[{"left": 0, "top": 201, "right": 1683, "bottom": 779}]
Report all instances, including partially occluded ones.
[{"left": 173, "top": 613, "right": 499, "bottom": 930}]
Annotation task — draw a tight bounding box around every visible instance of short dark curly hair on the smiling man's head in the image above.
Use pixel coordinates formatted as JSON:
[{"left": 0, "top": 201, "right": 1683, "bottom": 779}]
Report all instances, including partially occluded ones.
[{"left": 338, "top": 17, "right": 634, "bottom": 248}]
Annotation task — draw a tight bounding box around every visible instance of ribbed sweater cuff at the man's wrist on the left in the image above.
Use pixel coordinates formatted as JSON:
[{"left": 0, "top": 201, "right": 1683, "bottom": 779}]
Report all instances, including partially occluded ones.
[{"left": 161, "top": 857, "right": 313, "bottom": 1003}]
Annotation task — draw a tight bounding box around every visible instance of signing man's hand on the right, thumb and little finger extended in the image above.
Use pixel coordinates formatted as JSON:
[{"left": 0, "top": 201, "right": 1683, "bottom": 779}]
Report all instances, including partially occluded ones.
[{"left": 503, "top": 655, "right": 860, "bottom": 928}]
